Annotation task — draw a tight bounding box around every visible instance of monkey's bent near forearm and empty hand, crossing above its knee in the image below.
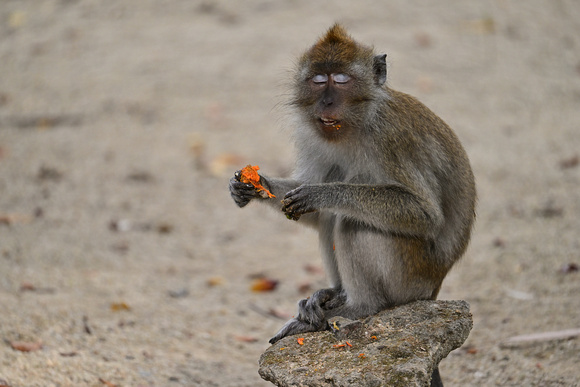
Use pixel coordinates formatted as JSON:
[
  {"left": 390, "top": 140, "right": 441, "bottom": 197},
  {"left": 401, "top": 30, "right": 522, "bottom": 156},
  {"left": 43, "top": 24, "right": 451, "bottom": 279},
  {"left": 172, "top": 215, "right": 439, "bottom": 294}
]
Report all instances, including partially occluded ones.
[{"left": 282, "top": 183, "right": 443, "bottom": 237}]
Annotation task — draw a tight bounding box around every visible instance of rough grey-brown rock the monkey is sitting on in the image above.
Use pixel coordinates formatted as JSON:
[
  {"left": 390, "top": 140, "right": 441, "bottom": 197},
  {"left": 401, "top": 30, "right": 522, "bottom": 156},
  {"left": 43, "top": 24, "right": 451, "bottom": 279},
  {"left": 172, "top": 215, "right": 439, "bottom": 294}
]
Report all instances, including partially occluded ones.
[{"left": 259, "top": 301, "right": 473, "bottom": 386}]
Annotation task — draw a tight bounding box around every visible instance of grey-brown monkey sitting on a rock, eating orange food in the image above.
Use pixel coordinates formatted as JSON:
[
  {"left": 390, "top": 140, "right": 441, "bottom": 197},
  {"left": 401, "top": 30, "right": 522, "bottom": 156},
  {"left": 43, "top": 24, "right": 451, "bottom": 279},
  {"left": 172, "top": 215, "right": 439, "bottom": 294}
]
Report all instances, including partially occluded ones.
[{"left": 229, "top": 24, "right": 476, "bottom": 385}]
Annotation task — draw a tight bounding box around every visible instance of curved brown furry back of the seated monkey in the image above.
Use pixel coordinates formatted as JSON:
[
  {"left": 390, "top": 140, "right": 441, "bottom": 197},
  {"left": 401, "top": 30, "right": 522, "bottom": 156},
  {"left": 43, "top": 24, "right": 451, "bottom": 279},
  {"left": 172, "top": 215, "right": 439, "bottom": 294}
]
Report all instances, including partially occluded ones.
[{"left": 383, "top": 89, "right": 476, "bottom": 268}]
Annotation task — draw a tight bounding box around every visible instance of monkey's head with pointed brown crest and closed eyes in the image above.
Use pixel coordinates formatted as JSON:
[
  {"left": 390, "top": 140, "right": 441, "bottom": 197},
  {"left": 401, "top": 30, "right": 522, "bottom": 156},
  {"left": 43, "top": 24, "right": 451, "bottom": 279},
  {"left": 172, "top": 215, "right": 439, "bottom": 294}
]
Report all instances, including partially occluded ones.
[{"left": 293, "top": 24, "right": 387, "bottom": 140}]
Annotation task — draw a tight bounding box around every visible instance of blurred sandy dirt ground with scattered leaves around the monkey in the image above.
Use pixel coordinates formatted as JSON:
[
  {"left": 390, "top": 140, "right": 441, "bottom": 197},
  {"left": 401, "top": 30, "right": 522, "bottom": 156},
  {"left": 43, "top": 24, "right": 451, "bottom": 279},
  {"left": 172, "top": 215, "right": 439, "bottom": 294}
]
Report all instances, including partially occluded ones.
[{"left": 0, "top": 0, "right": 580, "bottom": 387}]
